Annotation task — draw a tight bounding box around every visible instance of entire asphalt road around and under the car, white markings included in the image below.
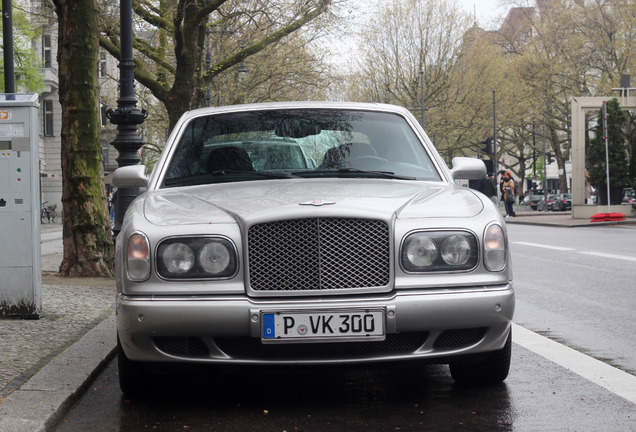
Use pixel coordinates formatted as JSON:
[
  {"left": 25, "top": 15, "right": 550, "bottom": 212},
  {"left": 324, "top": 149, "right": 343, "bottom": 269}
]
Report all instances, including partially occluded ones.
[{"left": 56, "top": 225, "right": 636, "bottom": 432}]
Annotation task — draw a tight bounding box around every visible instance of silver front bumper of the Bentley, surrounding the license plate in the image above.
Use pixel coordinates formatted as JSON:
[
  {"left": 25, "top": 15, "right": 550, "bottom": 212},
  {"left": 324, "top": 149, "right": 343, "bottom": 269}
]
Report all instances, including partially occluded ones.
[{"left": 117, "top": 283, "right": 515, "bottom": 364}]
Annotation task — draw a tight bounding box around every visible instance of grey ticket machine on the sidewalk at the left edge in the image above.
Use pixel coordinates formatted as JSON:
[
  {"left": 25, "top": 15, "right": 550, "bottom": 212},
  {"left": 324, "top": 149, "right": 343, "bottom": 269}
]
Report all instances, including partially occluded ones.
[{"left": 0, "top": 93, "right": 42, "bottom": 318}]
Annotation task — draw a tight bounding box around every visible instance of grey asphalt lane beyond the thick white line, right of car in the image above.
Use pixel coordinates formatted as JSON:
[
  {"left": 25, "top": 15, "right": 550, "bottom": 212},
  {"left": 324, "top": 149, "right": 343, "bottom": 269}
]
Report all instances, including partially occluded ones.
[{"left": 508, "top": 225, "right": 636, "bottom": 375}]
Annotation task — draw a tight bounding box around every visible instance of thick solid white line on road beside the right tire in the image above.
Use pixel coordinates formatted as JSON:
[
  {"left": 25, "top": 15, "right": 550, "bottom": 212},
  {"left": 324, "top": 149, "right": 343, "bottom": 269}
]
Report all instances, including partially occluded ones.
[{"left": 512, "top": 324, "right": 636, "bottom": 404}]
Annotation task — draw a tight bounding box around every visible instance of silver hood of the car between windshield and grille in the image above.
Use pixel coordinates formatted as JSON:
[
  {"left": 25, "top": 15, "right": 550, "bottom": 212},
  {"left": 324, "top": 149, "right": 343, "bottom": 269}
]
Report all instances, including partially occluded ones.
[{"left": 143, "top": 179, "right": 484, "bottom": 226}]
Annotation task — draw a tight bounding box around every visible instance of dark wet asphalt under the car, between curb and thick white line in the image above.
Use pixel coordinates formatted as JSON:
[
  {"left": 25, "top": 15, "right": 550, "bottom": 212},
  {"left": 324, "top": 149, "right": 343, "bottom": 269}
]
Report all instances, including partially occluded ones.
[{"left": 55, "top": 345, "right": 636, "bottom": 432}]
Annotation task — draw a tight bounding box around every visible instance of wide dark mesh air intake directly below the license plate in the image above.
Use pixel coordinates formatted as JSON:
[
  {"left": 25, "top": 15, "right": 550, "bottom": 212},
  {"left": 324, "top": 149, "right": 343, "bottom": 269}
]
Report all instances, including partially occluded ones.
[{"left": 215, "top": 332, "right": 428, "bottom": 360}]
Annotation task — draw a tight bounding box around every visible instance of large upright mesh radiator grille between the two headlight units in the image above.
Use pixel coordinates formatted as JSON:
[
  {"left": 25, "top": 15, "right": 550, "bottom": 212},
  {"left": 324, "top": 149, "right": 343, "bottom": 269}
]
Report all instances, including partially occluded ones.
[{"left": 248, "top": 218, "right": 390, "bottom": 292}]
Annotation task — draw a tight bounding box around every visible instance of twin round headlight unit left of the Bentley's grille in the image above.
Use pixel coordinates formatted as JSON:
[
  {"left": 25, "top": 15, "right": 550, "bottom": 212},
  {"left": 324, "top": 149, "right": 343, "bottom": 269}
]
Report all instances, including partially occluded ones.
[{"left": 157, "top": 237, "right": 238, "bottom": 279}]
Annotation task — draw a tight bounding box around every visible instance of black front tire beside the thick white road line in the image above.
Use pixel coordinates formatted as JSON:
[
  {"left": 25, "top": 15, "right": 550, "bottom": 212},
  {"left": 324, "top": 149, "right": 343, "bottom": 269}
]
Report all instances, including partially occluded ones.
[{"left": 449, "top": 329, "right": 512, "bottom": 386}]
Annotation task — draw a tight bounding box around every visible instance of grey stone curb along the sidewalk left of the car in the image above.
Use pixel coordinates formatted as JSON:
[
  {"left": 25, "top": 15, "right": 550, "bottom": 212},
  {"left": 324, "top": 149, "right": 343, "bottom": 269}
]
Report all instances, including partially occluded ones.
[{"left": 0, "top": 314, "right": 116, "bottom": 432}]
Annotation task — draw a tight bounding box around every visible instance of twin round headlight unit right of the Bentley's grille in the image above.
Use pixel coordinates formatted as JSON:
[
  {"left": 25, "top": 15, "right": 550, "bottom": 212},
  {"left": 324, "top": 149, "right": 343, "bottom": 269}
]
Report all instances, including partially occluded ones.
[{"left": 400, "top": 231, "right": 479, "bottom": 273}]
